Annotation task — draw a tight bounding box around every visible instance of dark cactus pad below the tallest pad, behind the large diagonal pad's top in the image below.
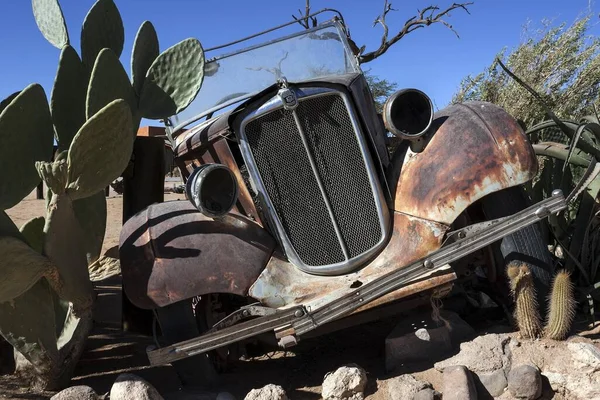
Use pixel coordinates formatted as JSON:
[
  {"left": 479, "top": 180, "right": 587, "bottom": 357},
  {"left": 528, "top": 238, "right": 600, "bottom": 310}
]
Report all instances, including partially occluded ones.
[{"left": 86, "top": 49, "right": 137, "bottom": 119}]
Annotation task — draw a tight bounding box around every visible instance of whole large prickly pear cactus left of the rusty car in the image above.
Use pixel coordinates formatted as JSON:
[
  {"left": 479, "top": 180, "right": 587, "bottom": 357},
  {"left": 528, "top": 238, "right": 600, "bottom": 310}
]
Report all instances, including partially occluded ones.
[{"left": 0, "top": 0, "right": 204, "bottom": 389}]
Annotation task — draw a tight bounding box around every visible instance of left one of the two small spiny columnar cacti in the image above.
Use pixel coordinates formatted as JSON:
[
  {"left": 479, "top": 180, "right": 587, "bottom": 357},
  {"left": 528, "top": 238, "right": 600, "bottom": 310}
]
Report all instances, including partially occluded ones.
[{"left": 507, "top": 263, "right": 542, "bottom": 338}]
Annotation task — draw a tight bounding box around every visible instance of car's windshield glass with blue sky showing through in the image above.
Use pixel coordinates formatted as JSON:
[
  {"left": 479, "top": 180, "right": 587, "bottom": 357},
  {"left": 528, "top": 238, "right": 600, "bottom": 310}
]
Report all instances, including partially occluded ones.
[{"left": 176, "top": 23, "right": 358, "bottom": 125}]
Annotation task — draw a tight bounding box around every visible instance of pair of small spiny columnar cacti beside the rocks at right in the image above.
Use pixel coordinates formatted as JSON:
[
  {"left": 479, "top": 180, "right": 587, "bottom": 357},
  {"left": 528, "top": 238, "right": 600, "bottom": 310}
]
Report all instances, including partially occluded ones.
[{"left": 507, "top": 264, "right": 575, "bottom": 340}]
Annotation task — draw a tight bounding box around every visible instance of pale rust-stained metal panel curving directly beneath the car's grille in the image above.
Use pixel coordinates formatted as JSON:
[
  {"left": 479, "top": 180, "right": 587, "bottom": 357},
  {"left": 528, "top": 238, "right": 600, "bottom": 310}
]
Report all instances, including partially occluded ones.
[{"left": 249, "top": 212, "right": 454, "bottom": 309}]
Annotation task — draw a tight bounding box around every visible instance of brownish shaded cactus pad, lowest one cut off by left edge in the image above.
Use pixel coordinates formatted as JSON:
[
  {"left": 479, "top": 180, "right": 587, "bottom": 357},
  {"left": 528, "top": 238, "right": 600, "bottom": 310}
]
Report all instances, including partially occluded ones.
[{"left": 0, "top": 236, "right": 53, "bottom": 303}]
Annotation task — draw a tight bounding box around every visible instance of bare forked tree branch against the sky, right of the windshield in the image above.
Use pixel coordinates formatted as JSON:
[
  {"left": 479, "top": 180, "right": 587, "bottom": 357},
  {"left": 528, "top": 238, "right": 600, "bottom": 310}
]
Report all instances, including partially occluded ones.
[{"left": 358, "top": 0, "right": 473, "bottom": 64}]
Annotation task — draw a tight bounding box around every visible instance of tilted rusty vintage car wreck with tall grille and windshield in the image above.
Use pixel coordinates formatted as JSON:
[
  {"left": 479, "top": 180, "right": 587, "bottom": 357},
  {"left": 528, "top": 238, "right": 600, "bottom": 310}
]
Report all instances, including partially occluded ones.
[{"left": 120, "top": 9, "right": 566, "bottom": 380}]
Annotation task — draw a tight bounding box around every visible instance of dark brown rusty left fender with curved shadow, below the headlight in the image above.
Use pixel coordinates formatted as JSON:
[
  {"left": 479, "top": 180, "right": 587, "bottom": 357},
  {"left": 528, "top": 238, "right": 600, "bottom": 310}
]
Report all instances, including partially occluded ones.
[{"left": 119, "top": 201, "right": 275, "bottom": 309}]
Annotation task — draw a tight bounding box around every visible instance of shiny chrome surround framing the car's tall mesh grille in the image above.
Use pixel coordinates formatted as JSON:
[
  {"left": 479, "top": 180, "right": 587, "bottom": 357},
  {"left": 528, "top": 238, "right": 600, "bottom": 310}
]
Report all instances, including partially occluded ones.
[{"left": 238, "top": 87, "right": 391, "bottom": 275}]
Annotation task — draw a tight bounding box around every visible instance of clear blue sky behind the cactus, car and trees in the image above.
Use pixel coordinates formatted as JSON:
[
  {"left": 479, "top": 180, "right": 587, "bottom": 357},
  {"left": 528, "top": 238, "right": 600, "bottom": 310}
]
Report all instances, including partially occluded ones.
[{"left": 0, "top": 0, "right": 600, "bottom": 120}]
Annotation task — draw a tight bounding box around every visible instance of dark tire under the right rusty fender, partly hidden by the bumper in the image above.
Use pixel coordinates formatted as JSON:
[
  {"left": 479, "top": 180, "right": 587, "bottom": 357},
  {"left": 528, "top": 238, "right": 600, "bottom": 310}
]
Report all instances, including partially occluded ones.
[{"left": 481, "top": 186, "right": 554, "bottom": 317}]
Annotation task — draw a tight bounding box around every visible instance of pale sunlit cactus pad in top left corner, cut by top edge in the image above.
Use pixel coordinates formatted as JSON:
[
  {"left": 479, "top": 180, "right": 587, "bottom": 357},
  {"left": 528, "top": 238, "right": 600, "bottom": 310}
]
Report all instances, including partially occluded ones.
[{"left": 31, "top": 0, "right": 69, "bottom": 49}]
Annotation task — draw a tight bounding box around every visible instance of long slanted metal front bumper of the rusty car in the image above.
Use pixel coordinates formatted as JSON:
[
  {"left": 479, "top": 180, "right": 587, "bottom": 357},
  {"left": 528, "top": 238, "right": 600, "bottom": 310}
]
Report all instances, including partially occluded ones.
[{"left": 148, "top": 190, "right": 567, "bottom": 365}]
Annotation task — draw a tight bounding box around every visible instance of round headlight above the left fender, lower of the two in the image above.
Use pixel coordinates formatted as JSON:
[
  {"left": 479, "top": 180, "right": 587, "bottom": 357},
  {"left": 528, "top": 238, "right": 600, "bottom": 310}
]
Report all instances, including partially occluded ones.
[{"left": 185, "top": 164, "right": 238, "bottom": 218}]
